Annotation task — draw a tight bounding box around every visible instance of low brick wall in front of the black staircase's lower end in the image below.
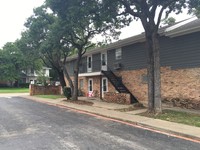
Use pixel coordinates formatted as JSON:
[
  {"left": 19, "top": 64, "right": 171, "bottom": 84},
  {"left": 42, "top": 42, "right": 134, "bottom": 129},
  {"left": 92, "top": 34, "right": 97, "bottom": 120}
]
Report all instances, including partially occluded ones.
[{"left": 103, "top": 92, "right": 131, "bottom": 104}]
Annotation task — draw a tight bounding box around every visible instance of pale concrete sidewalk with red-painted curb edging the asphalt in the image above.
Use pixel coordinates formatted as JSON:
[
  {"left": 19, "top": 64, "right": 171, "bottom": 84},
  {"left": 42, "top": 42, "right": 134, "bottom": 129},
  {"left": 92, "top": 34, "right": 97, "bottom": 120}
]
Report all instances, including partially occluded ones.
[{"left": 20, "top": 96, "right": 200, "bottom": 143}]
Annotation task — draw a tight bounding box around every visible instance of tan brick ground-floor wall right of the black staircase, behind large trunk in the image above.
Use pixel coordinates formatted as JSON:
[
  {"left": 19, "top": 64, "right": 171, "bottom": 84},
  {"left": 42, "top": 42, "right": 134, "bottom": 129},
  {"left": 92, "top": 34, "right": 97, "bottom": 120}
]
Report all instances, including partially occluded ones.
[{"left": 116, "top": 67, "right": 200, "bottom": 104}]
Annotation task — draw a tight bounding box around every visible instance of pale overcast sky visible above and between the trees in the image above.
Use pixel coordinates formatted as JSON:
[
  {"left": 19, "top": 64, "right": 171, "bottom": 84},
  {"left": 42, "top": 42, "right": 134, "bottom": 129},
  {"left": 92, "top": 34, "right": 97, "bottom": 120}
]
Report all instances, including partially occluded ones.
[{"left": 0, "top": 0, "right": 190, "bottom": 48}]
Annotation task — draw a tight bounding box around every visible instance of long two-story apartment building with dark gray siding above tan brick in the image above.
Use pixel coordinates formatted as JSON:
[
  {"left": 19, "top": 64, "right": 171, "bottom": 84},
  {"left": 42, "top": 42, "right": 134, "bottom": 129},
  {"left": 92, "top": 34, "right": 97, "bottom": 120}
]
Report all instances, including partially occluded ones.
[{"left": 66, "top": 18, "right": 200, "bottom": 104}]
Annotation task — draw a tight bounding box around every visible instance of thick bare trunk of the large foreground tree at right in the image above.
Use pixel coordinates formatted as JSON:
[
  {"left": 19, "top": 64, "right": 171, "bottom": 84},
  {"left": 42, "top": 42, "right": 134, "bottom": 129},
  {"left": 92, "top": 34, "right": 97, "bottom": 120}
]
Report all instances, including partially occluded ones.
[{"left": 146, "top": 31, "right": 162, "bottom": 113}]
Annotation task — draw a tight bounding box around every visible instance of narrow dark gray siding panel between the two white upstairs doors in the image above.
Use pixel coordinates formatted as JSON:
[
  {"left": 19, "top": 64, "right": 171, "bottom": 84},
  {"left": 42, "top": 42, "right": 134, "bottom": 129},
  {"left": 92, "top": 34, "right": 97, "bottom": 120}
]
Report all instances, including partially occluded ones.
[{"left": 92, "top": 53, "right": 101, "bottom": 72}]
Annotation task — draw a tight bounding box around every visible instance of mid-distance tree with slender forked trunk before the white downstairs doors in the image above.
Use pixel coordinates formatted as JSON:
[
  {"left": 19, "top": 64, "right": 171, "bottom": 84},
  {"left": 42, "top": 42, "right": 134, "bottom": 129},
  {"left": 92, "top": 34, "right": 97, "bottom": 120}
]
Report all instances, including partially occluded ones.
[{"left": 46, "top": 0, "right": 121, "bottom": 100}]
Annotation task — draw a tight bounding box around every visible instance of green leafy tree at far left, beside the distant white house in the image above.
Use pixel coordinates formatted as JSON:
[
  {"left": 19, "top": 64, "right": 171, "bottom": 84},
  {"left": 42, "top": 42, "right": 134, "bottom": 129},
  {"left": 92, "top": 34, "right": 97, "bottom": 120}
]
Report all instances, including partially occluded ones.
[{"left": 0, "top": 40, "right": 41, "bottom": 86}]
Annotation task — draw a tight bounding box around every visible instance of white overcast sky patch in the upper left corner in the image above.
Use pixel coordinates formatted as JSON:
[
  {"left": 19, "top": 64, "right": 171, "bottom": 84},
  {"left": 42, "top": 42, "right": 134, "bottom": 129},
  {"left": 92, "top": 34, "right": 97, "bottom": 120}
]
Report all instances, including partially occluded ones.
[{"left": 0, "top": 0, "right": 44, "bottom": 47}]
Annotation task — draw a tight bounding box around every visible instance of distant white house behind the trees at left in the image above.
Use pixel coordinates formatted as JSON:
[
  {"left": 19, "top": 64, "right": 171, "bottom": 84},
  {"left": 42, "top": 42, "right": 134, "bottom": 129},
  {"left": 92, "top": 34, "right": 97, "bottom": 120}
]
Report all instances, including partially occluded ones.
[{"left": 21, "top": 67, "right": 51, "bottom": 84}]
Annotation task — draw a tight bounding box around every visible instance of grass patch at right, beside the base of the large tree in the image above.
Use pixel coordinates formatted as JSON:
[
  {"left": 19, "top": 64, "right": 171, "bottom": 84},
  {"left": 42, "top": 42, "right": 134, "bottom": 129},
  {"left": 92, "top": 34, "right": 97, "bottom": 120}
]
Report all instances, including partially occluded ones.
[{"left": 139, "top": 110, "right": 200, "bottom": 127}]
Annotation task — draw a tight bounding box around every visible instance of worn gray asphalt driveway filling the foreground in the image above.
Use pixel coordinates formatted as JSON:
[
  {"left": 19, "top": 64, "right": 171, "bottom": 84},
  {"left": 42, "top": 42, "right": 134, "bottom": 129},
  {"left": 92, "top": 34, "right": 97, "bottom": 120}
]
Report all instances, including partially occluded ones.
[{"left": 0, "top": 96, "right": 200, "bottom": 150}]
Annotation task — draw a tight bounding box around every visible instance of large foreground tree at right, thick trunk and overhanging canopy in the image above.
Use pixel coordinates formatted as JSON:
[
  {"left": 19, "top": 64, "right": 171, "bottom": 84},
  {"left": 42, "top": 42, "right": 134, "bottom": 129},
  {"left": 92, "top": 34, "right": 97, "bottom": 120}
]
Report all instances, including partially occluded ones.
[{"left": 101, "top": 0, "right": 200, "bottom": 113}]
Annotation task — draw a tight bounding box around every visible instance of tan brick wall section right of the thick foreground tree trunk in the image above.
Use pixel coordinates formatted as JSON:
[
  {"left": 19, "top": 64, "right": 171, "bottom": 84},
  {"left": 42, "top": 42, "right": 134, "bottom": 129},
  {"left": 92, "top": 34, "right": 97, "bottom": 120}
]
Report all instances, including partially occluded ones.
[{"left": 161, "top": 67, "right": 200, "bottom": 101}]
